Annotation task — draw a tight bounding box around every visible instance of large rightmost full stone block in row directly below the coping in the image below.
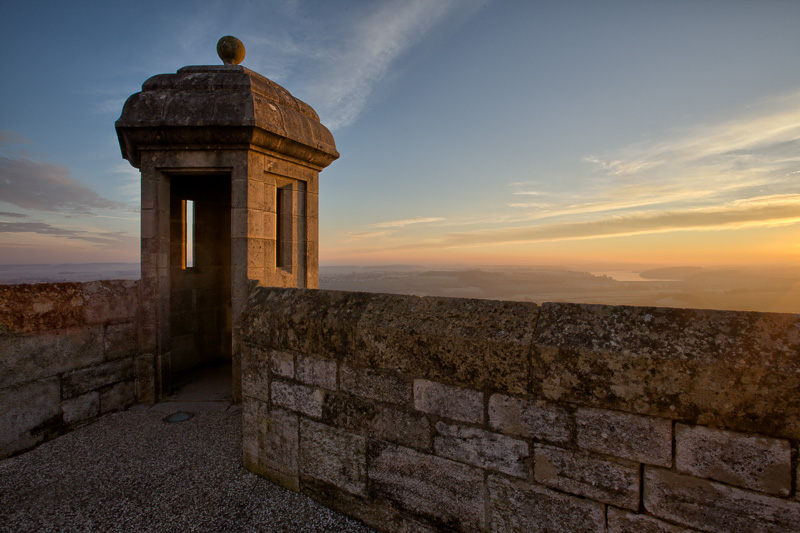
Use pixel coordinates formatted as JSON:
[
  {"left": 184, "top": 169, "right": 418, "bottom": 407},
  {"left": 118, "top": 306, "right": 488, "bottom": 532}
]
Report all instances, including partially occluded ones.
[{"left": 675, "top": 424, "right": 792, "bottom": 496}]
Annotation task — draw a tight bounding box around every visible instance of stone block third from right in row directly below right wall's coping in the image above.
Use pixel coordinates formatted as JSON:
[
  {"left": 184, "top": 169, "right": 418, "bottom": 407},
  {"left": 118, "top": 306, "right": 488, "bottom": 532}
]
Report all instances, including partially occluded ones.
[{"left": 489, "top": 394, "right": 572, "bottom": 443}]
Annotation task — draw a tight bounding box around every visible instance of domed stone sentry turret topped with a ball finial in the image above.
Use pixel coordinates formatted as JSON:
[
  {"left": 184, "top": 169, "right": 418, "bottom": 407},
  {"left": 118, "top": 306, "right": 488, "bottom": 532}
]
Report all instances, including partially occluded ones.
[{"left": 116, "top": 37, "right": 339, "bottom": 403}]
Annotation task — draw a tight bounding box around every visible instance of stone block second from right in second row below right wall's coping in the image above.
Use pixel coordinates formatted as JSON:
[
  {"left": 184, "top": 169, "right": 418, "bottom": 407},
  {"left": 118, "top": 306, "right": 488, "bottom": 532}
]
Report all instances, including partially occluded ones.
[{"left": 533, "top": 445, "right": 640, "bottom": 511}]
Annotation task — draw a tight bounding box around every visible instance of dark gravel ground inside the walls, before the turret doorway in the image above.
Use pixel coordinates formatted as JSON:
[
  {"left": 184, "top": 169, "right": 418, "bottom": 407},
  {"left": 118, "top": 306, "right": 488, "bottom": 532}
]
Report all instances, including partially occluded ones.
[{"left": 0, "top": 404, "right": 373, "bottom": 533}]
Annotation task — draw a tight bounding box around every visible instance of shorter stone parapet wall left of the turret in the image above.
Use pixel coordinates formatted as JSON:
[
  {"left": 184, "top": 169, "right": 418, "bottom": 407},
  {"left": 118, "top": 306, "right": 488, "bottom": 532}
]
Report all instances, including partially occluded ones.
[{"left": 0, "top": 281, "right": 138, "bottom": 458}]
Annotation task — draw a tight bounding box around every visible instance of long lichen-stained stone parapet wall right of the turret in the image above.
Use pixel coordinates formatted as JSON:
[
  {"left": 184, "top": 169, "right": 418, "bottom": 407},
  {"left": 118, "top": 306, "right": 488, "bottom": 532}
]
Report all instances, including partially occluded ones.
[{"left": 241, "top": 288, "right": 800, "bottom": 533}]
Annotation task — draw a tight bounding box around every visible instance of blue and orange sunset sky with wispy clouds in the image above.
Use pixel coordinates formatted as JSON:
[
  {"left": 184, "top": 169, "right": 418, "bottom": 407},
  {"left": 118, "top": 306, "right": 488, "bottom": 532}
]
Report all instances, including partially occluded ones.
[{"left": 0, "top": 0, "right": 800, "bottom": 266}]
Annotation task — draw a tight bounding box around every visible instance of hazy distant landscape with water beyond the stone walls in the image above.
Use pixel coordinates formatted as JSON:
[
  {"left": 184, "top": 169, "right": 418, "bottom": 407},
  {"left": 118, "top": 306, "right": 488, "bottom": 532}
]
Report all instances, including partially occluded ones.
[{"left": 0, "top": 263, "right": 800, "bottom": 313}]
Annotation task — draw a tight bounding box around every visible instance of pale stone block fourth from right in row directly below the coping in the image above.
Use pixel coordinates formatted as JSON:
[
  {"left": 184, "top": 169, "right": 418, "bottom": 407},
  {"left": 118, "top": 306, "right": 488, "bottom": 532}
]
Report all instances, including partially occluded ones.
[{"left": 414, "top": 379, "right": 483, "bottom": 424}]
